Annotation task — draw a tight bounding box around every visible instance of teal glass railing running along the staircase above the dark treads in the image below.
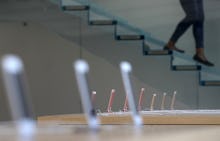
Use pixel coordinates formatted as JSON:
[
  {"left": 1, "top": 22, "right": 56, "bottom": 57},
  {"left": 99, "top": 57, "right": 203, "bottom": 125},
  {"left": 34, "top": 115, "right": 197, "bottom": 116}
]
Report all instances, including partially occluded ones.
[{"left": 51, "top": 0, "right": 220, "bottom": 74}]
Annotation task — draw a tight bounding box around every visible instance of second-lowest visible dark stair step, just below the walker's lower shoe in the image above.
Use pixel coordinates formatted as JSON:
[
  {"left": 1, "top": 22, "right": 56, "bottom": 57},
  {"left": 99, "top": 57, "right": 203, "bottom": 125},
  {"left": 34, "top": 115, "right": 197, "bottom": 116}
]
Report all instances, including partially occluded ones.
[{"left": 172, "top": 65, "right": 202, "bottom": 71}]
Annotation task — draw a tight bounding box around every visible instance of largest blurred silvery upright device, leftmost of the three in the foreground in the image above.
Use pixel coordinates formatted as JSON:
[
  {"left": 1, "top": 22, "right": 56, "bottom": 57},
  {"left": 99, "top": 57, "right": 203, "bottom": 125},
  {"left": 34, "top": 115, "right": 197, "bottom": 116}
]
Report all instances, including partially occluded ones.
[{"left": 1, "top": 54, "right": 36, "bottom": 141}]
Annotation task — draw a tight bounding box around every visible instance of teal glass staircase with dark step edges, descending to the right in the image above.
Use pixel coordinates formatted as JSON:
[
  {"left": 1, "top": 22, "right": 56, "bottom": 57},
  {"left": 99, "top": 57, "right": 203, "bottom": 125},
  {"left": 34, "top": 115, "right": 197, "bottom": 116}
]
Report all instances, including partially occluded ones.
[{"left": 50, "top": 0, "right": 220, "bottom": 86}]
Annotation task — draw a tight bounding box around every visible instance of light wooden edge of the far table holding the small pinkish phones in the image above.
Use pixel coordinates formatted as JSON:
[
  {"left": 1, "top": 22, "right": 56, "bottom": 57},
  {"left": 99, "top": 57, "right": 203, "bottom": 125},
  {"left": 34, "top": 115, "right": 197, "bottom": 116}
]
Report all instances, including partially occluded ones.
[{"left": 38, "top": 111, "right": 220, "bottom": 125}]
